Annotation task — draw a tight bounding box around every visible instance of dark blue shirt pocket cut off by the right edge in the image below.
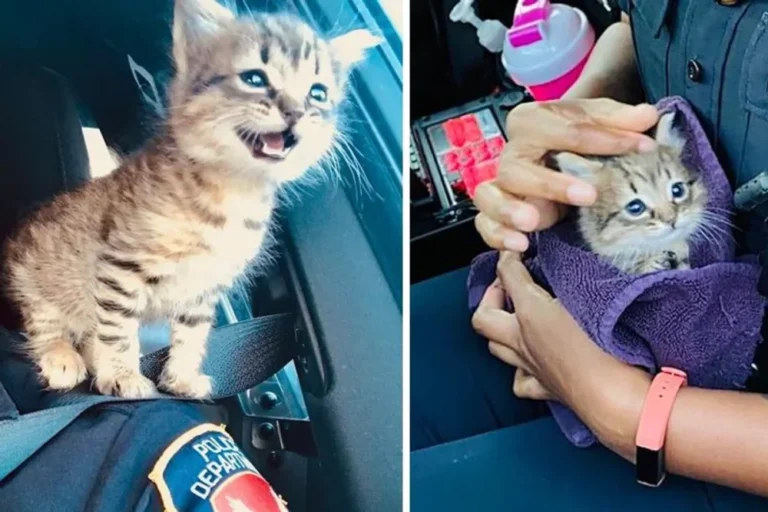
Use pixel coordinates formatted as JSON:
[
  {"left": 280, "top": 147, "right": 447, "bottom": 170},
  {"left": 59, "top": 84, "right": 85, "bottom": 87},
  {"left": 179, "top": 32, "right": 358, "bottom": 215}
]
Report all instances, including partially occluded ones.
[{"left": 739, "top": 11, "right": 768, "bottom": 121}]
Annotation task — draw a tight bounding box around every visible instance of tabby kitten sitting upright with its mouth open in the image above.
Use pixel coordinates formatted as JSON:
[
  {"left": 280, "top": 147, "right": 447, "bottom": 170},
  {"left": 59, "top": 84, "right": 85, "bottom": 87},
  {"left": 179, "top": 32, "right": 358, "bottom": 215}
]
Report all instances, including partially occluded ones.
[{"left": 4, "top": 0, "right": 378, "bottom": 398}]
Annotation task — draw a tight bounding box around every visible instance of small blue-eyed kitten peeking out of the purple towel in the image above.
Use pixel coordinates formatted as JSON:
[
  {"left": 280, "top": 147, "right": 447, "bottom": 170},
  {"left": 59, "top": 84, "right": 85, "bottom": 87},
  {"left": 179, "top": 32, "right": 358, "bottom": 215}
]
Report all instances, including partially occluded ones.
[{"left": 553, "top": 113, "right": 714, "bottom": 274}]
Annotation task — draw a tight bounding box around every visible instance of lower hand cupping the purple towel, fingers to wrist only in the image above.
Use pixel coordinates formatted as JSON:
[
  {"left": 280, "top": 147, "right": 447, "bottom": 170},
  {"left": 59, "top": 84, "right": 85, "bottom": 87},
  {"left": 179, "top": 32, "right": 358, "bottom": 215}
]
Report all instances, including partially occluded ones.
[{"left": 472, "top": 251, "right": 646, "bottom": 416}]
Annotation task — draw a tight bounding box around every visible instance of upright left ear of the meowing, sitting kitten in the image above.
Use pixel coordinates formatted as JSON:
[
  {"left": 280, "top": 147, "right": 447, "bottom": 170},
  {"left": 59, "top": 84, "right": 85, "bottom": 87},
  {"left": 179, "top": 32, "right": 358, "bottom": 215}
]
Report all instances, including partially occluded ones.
[{"left": 173, "top": 0, "right": 235, "bottom": 75}]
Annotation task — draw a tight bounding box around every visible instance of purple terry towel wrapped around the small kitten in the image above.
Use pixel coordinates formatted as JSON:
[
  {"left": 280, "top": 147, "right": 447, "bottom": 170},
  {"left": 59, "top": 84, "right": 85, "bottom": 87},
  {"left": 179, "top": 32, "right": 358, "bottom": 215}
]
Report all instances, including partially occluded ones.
[{"left": 468, "top": 97, "right": 764, "bottom": 446}]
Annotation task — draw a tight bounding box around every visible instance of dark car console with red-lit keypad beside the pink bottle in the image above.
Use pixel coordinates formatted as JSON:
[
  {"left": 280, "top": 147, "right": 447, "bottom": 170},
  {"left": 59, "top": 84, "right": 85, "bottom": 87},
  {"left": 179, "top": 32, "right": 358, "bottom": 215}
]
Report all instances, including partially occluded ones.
[{"left": 409, "top": 0, "right": 619, "bottom": 284}]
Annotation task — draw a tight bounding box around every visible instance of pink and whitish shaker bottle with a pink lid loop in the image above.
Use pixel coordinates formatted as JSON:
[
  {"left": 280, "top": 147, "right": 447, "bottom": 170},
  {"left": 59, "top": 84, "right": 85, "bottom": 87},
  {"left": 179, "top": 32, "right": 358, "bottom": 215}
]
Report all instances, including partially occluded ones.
[{"left": 502, "top": 0, "right": 595, "bottom": 100}]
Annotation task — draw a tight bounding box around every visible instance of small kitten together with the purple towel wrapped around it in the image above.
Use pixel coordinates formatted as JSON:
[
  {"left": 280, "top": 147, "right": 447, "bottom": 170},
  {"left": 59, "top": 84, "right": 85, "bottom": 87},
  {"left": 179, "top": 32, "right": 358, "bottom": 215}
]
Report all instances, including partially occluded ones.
[{"left": 468, "top": 97, "right": 764, "bottom": 446}]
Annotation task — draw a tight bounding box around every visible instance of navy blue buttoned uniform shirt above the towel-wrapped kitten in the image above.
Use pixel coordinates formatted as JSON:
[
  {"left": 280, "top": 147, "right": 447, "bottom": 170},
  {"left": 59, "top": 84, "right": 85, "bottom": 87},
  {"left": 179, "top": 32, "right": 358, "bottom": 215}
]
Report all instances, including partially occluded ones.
[{"left": 618, "top": 0, "right": 768, "bottom": 391}]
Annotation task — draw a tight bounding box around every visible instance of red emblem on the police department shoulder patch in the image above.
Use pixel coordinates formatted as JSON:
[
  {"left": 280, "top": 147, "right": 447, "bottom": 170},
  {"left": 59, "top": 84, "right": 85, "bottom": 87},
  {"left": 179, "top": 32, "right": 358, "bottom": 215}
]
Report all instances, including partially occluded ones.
[{"left": 211, "top": 472, "right": 281, "bottom": 512}]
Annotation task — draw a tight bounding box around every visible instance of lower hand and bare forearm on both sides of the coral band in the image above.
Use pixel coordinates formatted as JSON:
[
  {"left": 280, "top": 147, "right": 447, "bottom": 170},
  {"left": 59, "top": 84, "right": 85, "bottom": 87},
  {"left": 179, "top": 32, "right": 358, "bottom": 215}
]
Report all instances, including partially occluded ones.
[{"left": 472, "top": 262, "right": 768, "bottom": 497}]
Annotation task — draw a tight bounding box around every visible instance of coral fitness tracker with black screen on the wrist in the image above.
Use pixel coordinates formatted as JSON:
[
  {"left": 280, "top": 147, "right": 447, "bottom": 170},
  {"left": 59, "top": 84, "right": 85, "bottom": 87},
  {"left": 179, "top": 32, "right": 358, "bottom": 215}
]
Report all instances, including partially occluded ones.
[{"left": 635, "top": 367, "right": 688, "bottom": 487}]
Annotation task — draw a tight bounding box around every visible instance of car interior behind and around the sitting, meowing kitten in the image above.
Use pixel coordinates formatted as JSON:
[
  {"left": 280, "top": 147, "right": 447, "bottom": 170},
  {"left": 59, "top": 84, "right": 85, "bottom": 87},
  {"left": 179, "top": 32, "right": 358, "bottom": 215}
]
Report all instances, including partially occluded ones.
[{"left": 0, "top": 0, "right": 403, "bottom": 511}]
